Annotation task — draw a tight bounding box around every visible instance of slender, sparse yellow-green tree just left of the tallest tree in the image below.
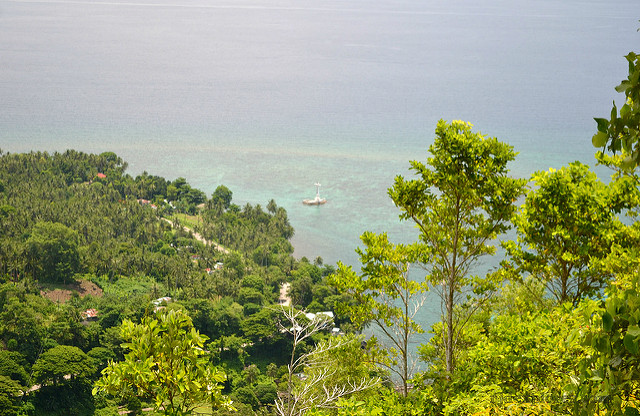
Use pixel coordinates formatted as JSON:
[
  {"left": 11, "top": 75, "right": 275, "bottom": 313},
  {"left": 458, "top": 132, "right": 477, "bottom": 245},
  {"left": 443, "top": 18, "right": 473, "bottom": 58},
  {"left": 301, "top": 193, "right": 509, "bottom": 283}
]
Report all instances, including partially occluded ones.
[{"left": 329, "top": 232, "right": 427, "bottom": 395}]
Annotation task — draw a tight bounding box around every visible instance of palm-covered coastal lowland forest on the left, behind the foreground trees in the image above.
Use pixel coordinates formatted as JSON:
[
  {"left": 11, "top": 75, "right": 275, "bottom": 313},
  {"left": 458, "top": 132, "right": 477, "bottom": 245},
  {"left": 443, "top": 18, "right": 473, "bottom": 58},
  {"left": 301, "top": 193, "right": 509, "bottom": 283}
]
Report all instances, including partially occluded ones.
[{"left": 0, "top": 151, "right": 349, "bottom": 415}]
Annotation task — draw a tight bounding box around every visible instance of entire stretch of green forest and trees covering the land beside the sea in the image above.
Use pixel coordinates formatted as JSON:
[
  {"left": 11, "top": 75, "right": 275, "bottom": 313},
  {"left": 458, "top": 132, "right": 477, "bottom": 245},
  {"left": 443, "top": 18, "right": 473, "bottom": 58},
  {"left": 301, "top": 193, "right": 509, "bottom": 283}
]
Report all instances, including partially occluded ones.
[{"left": 0, "top": 53, "right": 640, "bottom": 416}]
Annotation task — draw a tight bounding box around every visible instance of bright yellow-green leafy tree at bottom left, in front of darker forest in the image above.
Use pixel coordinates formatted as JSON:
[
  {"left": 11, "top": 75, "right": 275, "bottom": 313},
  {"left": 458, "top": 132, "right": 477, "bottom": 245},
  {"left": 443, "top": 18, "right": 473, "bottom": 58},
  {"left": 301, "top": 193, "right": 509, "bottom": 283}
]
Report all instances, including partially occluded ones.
[{"left": 94, "top": 309, "right": 230, "bottom": 416}]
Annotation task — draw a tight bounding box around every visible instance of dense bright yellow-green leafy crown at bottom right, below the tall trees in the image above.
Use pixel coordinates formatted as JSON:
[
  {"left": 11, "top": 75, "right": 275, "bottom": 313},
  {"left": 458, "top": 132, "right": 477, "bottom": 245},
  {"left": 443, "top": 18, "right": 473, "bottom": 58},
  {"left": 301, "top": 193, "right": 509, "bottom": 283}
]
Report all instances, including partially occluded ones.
[{"left": 425, "top": 305, "right": 587, "bottom": 415}]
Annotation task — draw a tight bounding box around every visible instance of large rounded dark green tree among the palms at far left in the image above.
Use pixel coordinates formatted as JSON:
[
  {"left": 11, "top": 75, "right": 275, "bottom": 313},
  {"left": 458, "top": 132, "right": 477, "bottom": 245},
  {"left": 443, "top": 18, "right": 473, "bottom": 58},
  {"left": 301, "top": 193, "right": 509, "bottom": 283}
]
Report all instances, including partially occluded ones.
[{"left": 27, "top": 221, "right": 80, "bottom": 283}]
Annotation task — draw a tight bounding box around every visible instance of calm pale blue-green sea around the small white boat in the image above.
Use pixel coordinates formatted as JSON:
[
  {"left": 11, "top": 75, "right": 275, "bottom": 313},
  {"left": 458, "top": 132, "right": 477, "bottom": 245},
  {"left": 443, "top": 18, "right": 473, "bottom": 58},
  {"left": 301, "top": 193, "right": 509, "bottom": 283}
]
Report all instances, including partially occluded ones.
[{"left": 0, "top": 0, "right": 640, "bottom": 352}]
